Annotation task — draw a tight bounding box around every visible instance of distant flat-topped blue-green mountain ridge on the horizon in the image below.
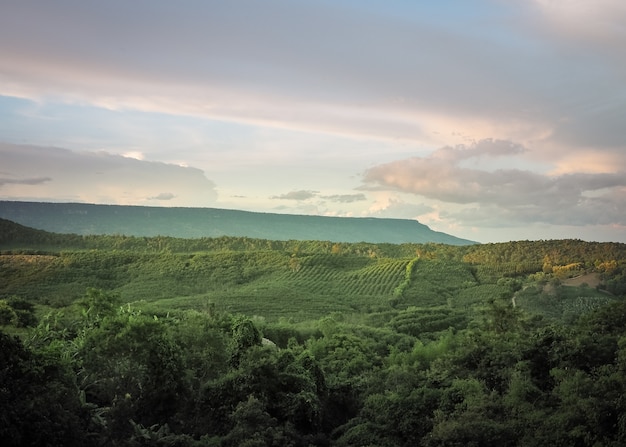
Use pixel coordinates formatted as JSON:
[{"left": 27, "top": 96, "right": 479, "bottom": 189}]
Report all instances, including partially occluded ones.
[{"left": 0, "top": 201, "right": 475, "bottom": 245}]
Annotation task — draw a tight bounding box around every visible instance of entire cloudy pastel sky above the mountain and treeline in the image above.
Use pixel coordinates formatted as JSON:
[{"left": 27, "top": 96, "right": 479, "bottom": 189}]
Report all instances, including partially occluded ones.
[{"left": 0, "top": 0, "right": 626, "bottom": 242}]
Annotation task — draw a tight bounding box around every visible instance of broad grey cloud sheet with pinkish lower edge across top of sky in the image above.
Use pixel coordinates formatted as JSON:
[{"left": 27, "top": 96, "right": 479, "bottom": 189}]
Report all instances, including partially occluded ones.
[{"left": 0, "top": 0, "right": 626, "bottom": 155}]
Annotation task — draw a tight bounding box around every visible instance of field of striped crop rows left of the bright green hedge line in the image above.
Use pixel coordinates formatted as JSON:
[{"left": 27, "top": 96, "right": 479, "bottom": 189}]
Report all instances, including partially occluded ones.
[{"left": 134, "top": 255, "right": 409, "bottom": 320}]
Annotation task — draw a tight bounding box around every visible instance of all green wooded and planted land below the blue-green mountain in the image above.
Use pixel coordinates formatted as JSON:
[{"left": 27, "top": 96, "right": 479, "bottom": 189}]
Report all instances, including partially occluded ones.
[{"left": 0, "top": 219, "right": 626, "bottom": 447}]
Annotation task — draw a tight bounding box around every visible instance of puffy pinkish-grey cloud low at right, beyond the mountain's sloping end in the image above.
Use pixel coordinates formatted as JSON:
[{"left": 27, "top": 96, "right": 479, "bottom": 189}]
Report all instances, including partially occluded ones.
[{"left": 364, "top": 141, "right": 626, "bottom": 226}]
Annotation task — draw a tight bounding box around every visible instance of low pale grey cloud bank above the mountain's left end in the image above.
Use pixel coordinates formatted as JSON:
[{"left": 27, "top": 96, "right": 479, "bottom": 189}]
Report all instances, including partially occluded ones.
[{"left": 0, "top": 143, "right": 217, "bottom": 206}]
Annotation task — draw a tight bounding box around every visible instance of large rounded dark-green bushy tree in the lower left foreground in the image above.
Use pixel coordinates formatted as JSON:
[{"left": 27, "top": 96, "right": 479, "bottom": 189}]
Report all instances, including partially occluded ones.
[{"left": 78, "top": 312, "right": 188, "bottom": 439}]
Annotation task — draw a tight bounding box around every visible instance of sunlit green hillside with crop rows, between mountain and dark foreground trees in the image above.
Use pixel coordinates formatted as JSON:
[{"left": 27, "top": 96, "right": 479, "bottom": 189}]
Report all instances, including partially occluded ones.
[{"left": 0, "top": 219, "right": 626, "bottom": 321}]
